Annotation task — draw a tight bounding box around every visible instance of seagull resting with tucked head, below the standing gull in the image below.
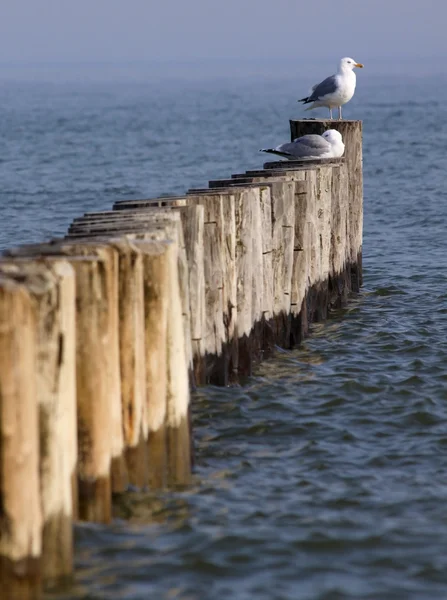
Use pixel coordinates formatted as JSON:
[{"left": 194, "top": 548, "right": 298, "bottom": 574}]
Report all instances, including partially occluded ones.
[{"left": 261, "top": 129, "right": 345, "bottom": 160}]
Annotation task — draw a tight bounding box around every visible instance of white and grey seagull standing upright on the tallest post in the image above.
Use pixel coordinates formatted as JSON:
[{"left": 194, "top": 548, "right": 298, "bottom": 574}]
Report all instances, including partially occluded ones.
[{"left": 298, "top": 58, "right": 363, "bottom": 120}]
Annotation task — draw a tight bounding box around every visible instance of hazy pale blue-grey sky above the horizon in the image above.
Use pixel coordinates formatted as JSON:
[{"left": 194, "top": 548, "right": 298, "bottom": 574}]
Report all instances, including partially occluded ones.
[{"left": 0, "top": 0, "right": 447, "bottom": 70}]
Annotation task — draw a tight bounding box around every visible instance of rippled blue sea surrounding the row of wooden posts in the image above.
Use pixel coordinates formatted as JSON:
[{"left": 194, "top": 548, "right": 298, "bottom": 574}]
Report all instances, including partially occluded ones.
[{"left": 0, "top": 64, "right": 447, "bottom": 600}]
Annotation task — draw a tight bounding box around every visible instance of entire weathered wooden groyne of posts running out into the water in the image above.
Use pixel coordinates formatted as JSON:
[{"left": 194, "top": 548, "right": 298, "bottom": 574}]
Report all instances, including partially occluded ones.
[{"left": 0, "top": 120, "right": 362, "bottom": 600}]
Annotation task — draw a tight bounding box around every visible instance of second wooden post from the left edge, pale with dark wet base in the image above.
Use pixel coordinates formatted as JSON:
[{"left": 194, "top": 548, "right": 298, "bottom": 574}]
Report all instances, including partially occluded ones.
[{"left": 0, "top": 260, "right": 77, "bottom": 587}]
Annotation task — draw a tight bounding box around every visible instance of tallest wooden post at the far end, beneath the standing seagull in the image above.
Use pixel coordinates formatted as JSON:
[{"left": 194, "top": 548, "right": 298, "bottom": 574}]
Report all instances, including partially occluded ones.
[{"left": 290, "top": 119, "right": 363, "bottom": 291}]
